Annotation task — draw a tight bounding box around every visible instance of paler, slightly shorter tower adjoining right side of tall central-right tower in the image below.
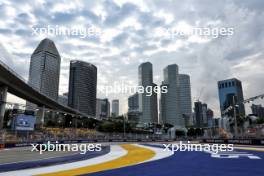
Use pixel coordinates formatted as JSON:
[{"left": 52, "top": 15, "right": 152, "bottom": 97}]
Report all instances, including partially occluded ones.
[{"left": 179, "top": 74, "right": 192, "bottom": 122}]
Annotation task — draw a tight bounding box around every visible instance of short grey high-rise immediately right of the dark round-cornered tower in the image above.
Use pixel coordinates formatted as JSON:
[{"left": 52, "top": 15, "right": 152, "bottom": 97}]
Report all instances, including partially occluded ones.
[{"left": 96, "top": 98, "right": 110, "bottom": 119}]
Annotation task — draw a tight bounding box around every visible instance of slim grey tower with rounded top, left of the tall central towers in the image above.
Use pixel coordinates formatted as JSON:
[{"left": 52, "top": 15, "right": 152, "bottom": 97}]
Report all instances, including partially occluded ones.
[{"left": 138, "top": 62, "right": 158, "bottom": 123}]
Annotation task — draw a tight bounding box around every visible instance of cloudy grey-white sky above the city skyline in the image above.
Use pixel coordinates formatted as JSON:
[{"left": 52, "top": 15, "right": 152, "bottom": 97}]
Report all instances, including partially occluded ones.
[{"left": 0, "top": 0, "right": 264, "bottom": 114}]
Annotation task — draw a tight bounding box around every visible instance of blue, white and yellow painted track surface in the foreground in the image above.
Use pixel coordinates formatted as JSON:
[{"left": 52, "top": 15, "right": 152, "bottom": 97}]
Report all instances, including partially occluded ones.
[{"left": 0, "top": 144, "right": 264, "bottom": 176}]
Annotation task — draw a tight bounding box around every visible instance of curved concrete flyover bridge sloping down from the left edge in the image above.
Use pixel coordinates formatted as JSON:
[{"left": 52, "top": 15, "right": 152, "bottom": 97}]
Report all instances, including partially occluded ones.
[{"left": 0, "top": 60, "right": 88, "bottom": 129}]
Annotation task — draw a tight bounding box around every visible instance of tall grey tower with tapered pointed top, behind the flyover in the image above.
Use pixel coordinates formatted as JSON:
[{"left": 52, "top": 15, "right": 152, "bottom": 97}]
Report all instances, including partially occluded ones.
[{"left": 27, "top": 38, "right": 61, "bottom": 108}]
